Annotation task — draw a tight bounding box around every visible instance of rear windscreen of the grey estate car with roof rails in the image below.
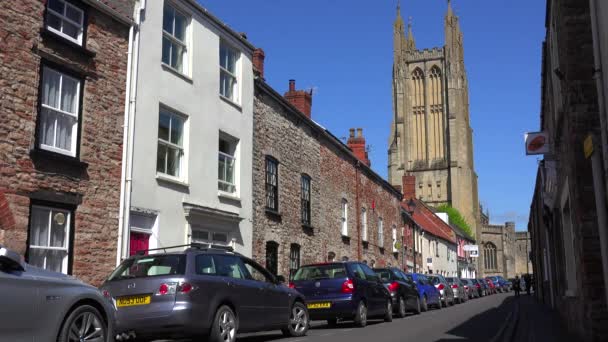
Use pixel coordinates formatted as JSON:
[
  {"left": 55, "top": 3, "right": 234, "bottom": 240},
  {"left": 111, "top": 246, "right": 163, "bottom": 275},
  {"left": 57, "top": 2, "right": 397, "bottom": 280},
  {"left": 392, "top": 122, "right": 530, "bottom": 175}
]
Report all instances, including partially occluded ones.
[{"left": 108, "top": 254, "right": 186, "bottom": 281}]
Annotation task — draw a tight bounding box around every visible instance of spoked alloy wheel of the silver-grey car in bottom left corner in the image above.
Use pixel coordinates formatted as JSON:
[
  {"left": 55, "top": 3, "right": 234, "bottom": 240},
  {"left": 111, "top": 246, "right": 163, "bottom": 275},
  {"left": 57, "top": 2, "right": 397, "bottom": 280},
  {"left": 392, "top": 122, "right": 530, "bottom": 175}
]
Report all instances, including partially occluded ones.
[{"left": 57, "top": 305, "right": 108, "bottom": 342}]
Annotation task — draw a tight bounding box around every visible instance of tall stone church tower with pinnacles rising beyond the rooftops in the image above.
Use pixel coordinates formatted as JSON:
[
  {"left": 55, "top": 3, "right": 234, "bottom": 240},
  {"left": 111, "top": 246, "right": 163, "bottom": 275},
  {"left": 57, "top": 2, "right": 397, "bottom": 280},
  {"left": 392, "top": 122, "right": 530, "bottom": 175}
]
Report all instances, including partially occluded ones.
[{"left": 388, "top": 0, "right": 479, "bottom": 238}]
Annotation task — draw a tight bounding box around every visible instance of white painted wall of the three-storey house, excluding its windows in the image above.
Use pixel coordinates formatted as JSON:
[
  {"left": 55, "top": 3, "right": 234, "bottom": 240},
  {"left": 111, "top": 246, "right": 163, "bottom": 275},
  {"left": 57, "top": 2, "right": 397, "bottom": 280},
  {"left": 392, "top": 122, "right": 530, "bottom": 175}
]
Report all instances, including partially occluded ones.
[{"left": 131, "top": 0, "right": 253, "bottom": 255}]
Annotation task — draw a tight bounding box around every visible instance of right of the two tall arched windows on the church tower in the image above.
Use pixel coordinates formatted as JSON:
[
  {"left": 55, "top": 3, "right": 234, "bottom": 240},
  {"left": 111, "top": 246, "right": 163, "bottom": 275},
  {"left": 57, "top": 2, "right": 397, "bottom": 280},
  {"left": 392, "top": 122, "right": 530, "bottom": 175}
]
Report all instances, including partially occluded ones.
[{"left": 428, "top": 66, "right": 445, "bottom": 163}]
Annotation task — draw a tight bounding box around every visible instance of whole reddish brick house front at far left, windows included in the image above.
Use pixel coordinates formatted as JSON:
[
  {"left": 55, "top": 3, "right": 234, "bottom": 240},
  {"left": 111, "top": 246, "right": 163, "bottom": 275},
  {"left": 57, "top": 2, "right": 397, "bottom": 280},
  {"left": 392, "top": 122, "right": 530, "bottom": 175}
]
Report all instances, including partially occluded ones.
[{"left": 0, "top": 0, "right": 133, "bottom": 284}]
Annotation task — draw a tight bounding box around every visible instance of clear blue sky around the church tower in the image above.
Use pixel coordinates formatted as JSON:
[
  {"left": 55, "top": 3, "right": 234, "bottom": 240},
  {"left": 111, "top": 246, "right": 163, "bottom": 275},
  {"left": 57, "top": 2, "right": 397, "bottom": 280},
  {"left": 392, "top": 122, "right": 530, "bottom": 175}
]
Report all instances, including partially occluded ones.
[{"left": 199, "top": 0, "right": 545, "bottom": 230}]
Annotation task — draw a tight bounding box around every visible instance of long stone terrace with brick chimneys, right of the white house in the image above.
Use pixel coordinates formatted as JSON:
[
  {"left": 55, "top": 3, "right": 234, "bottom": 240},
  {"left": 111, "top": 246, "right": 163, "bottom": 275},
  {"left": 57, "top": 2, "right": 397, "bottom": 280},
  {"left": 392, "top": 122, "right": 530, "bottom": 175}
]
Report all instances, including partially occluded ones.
[{"left": 253, "top": 75, "right": 403, "bottom": 277}]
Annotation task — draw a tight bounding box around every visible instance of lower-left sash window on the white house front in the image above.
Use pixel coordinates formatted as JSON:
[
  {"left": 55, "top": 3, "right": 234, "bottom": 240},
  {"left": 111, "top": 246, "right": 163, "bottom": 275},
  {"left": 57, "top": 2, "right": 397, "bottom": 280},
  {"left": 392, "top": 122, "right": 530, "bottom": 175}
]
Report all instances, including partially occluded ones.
[{"left": 156, "top": 108, "right": 185, "bottom": 179}]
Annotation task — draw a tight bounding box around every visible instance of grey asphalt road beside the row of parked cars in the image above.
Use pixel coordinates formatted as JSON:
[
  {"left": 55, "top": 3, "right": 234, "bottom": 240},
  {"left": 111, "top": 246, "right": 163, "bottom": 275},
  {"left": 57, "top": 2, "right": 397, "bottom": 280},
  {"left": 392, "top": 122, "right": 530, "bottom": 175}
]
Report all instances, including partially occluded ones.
[{"left": 237, "top": 292, "right": 513, "bottom": 342}]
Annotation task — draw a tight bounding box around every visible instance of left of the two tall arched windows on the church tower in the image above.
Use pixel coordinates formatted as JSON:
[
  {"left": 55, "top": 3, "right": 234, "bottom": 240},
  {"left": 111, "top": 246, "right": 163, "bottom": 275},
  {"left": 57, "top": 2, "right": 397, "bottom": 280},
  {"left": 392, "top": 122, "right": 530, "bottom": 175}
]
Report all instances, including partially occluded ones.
[{"left": 410, "top": 68, "right": 427, "bottom": 168}]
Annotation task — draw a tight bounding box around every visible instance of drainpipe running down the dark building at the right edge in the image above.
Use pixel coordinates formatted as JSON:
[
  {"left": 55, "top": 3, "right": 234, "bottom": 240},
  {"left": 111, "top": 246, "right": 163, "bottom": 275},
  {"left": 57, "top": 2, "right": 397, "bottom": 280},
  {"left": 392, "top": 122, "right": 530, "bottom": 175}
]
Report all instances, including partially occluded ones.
[{"left": 589, "top": 0, "right": 608, "bottom": 310}]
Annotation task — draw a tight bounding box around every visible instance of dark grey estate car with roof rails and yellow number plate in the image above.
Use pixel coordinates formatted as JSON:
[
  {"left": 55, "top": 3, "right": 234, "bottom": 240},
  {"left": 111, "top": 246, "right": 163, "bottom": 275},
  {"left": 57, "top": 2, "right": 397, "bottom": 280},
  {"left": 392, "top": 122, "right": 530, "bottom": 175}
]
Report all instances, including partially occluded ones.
[{"left": 101, "top": 244, "right": 309, "bottom": 342}]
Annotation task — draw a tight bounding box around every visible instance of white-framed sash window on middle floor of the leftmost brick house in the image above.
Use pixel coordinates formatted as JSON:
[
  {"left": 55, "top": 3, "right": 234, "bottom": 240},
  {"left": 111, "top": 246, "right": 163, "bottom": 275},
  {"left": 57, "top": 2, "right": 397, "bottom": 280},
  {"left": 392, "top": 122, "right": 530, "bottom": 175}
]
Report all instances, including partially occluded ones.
[{"left": 38, "top": 66, "right": 81, "bottom": 157}]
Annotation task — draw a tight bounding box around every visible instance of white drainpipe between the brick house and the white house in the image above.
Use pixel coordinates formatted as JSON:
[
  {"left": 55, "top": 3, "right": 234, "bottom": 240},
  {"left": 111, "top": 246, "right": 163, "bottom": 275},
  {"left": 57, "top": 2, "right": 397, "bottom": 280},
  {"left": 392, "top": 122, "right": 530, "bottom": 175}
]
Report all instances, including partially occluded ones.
[{"left": 116, "top": 0, "right": 146, "bottom": 264}]
